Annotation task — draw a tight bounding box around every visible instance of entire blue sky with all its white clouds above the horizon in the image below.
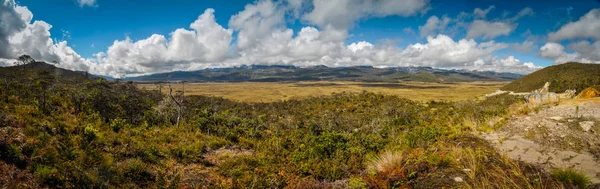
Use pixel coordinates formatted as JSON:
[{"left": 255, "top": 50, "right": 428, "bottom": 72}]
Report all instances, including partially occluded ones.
[{"left": 0, "top": 0, "right": 600, "bottom": 77}]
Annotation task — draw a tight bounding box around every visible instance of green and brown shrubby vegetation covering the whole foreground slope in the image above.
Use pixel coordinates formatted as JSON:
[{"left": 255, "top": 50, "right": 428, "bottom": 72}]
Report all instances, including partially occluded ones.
[{"left": 0, "top": 62, "right": 584, "bottom": 188}]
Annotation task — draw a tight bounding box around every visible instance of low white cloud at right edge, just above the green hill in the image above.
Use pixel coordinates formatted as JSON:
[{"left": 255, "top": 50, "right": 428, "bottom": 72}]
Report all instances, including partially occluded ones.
[{"left": 539, "top": 41, "right": 600, "bottom": 64}]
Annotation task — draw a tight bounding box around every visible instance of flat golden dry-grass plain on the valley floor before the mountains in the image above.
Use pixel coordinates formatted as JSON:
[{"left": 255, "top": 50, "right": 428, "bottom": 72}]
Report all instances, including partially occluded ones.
[{"left": 138, "top": 82, "right": 506, "bottom": 102}]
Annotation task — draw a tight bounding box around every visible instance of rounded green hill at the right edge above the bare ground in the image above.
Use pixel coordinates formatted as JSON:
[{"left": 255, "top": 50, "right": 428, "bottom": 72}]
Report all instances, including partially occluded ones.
[{"left": 501, "top": 62, "right": 600, "bottom": 92}]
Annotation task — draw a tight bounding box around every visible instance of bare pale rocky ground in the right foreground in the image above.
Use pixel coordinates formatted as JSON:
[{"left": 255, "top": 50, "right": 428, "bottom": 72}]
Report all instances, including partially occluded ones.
[{"left": 481, "top": 99, "right": 600, "bottom": 183}]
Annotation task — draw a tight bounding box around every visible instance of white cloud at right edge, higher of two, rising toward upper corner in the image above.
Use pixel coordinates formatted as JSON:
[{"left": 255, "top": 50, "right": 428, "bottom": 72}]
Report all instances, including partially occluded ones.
[{"left": 548, "top": 9, "right": 600, "bottom": 41}]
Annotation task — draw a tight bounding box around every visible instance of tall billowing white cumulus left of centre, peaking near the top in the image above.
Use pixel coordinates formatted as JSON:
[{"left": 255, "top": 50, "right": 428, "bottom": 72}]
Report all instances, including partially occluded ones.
[{"left": 97, "top": 9, "right": 232, "bottom": 75}]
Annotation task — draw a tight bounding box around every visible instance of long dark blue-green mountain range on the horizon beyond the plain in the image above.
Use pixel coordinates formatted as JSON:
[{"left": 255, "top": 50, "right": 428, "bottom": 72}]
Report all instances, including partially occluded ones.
[{"left": 124, "top": 65, "right": 522, "bottom": 82}]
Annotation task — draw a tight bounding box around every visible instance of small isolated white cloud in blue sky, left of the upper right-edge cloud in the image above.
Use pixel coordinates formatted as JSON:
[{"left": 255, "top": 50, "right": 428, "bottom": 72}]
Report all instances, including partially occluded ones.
[{"left": 467, "top": 20, "right": 517, "bottom": 39}]
